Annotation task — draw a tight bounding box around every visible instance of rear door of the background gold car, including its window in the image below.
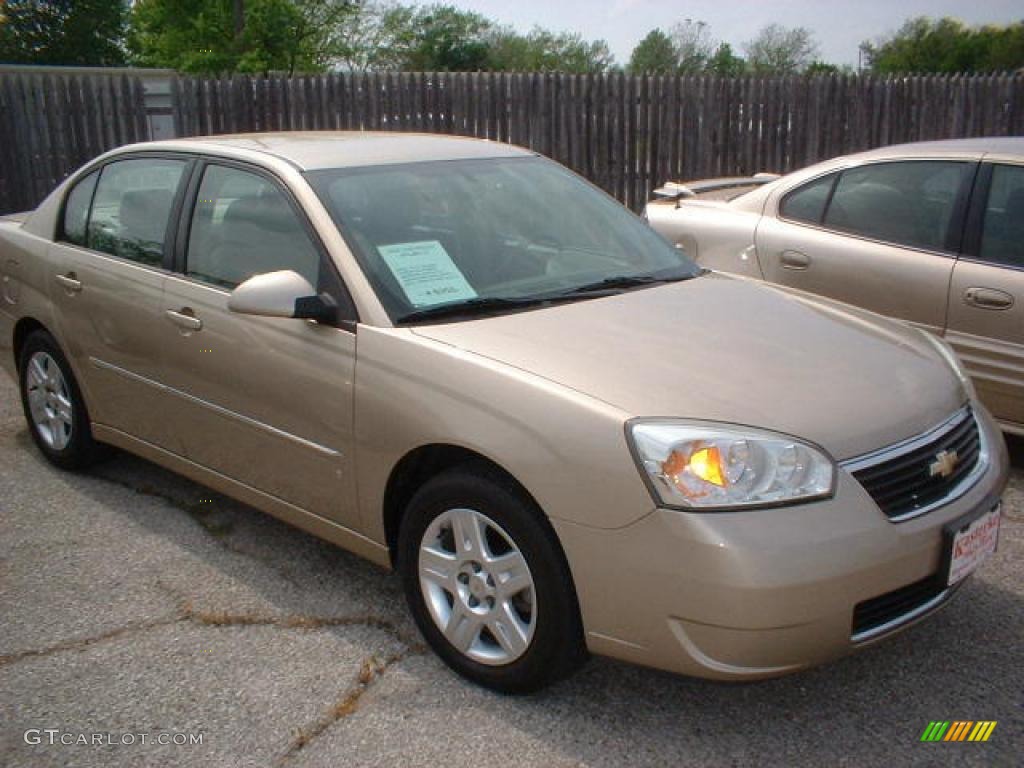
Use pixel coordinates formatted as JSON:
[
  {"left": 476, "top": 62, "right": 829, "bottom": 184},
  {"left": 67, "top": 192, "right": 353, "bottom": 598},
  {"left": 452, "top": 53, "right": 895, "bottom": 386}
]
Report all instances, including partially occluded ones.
[{"left": 755, "top": 160, "right": 977, "bottom": 333}]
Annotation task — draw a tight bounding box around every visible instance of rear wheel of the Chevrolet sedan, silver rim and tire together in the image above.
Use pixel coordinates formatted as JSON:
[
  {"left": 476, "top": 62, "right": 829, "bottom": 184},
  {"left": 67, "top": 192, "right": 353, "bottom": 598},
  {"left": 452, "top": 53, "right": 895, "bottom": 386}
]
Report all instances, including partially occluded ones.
[{"left": 18, "top": 331, "right": 102, "bottom": 469}]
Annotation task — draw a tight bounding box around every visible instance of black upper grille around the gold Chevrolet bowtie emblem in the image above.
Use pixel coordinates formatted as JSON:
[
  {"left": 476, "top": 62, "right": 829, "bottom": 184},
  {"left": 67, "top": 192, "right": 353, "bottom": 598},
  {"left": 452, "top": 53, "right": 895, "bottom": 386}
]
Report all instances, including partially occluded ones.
[{"left": 847, "top": 409, "right": 981, "bottom": 520}]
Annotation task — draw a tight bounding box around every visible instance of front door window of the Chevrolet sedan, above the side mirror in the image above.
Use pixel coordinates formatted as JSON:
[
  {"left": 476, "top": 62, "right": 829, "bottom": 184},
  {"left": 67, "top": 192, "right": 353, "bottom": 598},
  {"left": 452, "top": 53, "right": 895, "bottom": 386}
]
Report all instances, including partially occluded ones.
[{"left": 185, "top": 165, "right": 321, "bottom": 289}]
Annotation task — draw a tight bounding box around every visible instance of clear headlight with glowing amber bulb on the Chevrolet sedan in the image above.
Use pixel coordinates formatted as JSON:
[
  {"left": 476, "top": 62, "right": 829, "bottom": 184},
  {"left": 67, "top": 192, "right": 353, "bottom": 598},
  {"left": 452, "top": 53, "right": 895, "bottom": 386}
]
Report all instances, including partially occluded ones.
[{"left": 627, "top": 421, "right": 836, "bottom": 510}]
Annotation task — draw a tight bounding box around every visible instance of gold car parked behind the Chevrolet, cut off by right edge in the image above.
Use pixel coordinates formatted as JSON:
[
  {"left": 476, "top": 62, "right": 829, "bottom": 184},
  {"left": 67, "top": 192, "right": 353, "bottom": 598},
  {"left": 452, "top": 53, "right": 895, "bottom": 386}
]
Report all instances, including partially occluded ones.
[{"left": 646, "top": 138, "right": 1024, "bottom": 434}]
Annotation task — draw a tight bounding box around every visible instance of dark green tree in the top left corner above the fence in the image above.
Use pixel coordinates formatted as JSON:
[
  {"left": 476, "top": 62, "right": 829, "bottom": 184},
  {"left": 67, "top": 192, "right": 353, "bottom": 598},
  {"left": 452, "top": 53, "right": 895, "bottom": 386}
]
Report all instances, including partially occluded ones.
[{"left": 0, "top": 0, "right": 128, "bottom": 67}]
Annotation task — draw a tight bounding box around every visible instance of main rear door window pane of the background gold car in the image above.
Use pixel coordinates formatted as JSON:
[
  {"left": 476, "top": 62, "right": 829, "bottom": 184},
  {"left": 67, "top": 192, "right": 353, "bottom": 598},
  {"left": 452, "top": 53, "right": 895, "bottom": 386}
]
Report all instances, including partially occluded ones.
[{"left": 824, "top": 160, "right": 971, "bottom": 251}]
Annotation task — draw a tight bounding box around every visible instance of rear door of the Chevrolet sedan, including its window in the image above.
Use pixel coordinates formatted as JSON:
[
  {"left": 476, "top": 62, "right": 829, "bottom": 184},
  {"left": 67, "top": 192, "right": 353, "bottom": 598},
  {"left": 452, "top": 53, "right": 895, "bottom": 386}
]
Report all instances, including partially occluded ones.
[{"left": 50, "top": 156, "right": 191, "bottom": 451}]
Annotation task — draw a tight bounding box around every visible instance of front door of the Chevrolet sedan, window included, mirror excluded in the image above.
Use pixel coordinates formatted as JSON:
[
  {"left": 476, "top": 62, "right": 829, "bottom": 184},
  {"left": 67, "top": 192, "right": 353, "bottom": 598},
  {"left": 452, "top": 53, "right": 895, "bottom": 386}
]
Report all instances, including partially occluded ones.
[{"left": 153, "top": 162, "right": 355, "bottom": 527}]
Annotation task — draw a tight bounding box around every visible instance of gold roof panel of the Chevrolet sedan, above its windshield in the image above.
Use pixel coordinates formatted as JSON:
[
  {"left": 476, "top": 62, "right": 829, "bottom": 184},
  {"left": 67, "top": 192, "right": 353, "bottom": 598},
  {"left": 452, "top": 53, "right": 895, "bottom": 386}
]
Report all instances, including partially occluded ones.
[{"left": 131, "top": 131, "right": 536, "bottom": 171}]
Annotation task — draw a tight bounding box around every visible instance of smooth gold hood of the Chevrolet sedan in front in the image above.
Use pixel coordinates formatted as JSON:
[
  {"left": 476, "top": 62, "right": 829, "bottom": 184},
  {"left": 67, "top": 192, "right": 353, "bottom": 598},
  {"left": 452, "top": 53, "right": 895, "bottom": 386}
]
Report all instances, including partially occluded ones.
[{"left": 415, "top": 273, "right": 966, "bottom": 460}]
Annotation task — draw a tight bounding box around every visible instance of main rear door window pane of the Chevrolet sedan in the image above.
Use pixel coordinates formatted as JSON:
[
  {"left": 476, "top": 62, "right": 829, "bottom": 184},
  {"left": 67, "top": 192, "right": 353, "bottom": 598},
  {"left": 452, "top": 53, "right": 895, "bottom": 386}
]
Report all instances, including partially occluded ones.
[{"left": 88, "top": 158, "right": 185, "bottom": 266}]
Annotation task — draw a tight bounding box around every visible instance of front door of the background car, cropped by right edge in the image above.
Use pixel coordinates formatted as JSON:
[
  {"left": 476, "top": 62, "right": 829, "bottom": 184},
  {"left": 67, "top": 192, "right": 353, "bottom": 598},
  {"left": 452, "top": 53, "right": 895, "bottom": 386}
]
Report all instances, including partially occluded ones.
[{"left": 946, "top": 160, "right": 1024, "bottom": 433}]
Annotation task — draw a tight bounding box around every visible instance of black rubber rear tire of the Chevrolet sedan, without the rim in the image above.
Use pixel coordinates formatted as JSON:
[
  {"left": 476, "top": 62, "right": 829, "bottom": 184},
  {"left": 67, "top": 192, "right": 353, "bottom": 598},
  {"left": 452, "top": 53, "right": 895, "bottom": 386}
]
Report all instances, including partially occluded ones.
[{"left": 17, "top": 331, "right": 105, "bottom": 470}]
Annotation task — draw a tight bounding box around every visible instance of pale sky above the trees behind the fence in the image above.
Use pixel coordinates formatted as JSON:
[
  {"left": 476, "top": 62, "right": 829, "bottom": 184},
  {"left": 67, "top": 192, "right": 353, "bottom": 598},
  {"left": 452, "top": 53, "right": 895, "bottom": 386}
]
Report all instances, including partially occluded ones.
[{"left": 443, "top": 0, "right": 1024, "bottom": 67}]
